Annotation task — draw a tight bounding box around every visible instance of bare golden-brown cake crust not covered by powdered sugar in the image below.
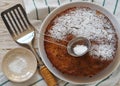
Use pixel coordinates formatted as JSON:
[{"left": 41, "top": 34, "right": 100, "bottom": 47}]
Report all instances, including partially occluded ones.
[{"left": 44, "top": 7, "right": 117, "bottom": 77}]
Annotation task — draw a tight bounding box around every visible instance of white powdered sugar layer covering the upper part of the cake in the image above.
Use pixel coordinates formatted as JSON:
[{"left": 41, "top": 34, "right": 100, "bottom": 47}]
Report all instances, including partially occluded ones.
[{"left": 49, "top": 8, "right": 117, "bottom": 60}]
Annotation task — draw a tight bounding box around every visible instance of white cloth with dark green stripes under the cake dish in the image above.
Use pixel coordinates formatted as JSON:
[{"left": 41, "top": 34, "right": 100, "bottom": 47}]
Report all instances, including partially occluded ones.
[{"left": 0, "top": 0, "right": 120, "bottom": 86}]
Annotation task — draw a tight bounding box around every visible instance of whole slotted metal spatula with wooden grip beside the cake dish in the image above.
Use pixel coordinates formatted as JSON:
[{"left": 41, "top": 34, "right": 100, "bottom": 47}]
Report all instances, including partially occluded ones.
[{"left": 1, "top": 4, "right": 57, "bottom": 86}]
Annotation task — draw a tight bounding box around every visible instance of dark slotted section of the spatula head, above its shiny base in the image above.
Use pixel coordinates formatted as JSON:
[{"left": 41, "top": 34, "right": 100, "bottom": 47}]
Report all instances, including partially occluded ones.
[{"left": 1, "top": 4, "right": 34, "bottom": 37}]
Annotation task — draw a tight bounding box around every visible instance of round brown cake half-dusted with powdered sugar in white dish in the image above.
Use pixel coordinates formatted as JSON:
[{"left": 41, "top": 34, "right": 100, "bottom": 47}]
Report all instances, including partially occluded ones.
[{"left": 44, "top": 7, "right": 118, "bottom": 77}]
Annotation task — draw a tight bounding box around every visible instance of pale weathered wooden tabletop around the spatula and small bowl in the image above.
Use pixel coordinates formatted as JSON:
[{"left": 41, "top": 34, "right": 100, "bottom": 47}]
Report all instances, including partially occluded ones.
[{"left": 0, "top": 0, "right": 120, "bottom": 86}]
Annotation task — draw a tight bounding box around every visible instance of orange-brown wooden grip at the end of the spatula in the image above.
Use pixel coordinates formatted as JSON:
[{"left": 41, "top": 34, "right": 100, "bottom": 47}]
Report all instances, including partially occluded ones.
[{"left": 39, "top": 65, "right": 58, "bottom": 86}]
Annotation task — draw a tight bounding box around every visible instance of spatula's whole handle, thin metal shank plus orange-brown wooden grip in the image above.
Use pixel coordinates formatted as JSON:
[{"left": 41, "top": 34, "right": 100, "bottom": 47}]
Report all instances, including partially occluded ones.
[{"left": 29, "top": 44, "right": 57, "bottom": 86}]
